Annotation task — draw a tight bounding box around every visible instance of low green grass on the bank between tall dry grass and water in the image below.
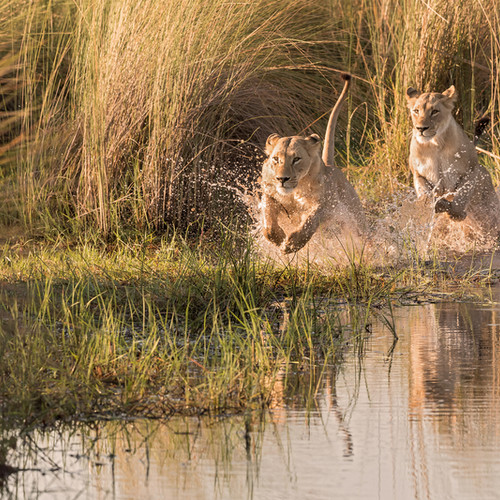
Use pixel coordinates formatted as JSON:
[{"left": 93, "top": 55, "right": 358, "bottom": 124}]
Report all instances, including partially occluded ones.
[{"left": 0, "top": 229, "right": 490, "bottom": 425}]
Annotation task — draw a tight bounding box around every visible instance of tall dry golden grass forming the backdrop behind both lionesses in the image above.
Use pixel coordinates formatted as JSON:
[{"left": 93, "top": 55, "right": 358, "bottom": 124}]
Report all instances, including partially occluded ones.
[{"left": 3, "top": 0, "right": 500, "bottom": 236}]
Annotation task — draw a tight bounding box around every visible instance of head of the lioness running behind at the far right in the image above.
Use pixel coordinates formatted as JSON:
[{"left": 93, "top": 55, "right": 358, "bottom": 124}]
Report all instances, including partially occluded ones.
[{"left": 406, "top": 85, "right": 457, "bottom": 144}]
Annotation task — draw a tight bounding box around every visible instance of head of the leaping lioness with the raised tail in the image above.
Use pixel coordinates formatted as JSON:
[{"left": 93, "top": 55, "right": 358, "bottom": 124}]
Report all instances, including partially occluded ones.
[{"left": 262, "top": 134, "right": 322, "bottom": 195}]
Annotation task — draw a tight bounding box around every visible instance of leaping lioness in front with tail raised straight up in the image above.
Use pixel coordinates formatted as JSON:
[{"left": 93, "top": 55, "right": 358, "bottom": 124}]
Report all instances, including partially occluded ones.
[{"left": 261, "top": 74, "right": 366, "bottom": 254}]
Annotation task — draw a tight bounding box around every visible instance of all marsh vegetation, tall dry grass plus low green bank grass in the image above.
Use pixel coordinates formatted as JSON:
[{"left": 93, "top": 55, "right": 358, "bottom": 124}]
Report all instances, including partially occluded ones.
[{"left": 0, "top": 0, "right": 500, "bottom": 430}]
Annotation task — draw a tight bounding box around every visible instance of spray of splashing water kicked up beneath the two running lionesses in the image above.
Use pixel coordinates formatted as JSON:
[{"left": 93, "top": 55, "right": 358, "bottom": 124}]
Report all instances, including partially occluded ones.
[{"left": 244, "top": 184, "right": 498, "bottom": 266}]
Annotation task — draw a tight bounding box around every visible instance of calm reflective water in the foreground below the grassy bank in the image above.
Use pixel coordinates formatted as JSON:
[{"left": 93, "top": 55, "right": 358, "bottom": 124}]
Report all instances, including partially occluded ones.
[{"left": 4, "top": 289, "right": 500, "bottom": 500}]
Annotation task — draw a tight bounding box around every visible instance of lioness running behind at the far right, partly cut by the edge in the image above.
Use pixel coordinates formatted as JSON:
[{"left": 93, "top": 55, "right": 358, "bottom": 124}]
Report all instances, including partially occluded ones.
[{"left": 406, "top": 85, "right": 500, "bottom": 240}]
